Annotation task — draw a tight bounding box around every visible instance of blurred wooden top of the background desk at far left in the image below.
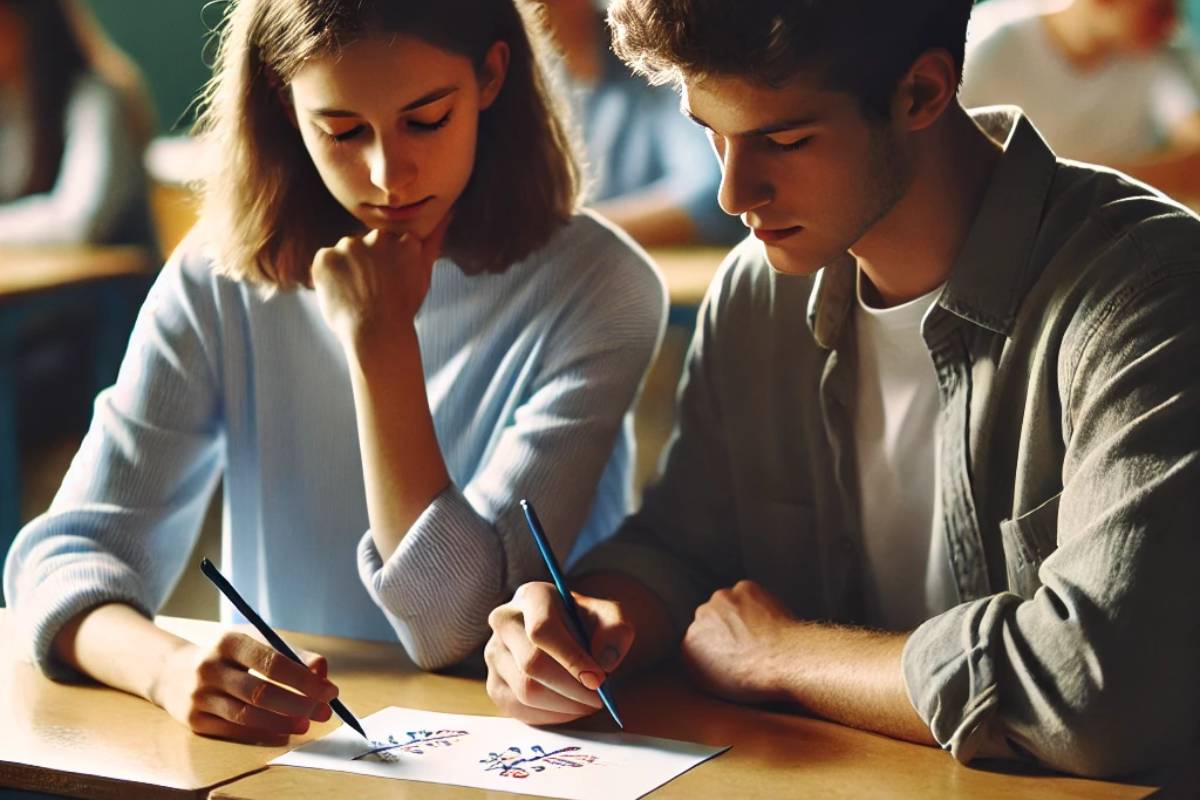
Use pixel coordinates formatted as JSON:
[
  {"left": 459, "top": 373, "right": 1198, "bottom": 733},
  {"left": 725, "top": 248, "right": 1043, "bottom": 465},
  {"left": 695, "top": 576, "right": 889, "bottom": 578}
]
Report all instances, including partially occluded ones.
[{"left": 0, "top": 245, "right": 156, "bottom": 301}]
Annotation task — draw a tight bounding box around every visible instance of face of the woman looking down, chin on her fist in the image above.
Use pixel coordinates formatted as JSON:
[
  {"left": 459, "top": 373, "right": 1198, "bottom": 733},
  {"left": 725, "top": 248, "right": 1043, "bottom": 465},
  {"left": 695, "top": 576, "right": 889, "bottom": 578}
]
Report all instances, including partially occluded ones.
[{"left": 290, "top": 35, "right": 508, "bottom": 237}]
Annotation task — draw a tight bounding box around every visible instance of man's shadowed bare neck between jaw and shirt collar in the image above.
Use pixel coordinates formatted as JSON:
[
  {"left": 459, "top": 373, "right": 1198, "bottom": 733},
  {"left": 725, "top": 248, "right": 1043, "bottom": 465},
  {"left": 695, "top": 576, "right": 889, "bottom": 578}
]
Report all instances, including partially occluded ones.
[{"left": 853, "top": 103, "right": 1002, "bottom": 306}]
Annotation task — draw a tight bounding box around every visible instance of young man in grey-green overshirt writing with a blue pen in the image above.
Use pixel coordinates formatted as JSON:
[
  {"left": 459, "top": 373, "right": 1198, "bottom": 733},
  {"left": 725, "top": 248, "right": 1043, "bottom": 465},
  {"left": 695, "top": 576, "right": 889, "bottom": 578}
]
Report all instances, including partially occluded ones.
[{"left": 486, "top": 0, "right": 1200, "bottom": 775}]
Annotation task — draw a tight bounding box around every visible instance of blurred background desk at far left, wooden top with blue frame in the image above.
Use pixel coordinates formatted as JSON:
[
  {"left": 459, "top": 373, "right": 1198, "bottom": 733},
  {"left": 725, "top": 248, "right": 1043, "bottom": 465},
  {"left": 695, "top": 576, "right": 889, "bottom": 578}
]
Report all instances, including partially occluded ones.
[{"left": 0, "top": 246, "right": 157, "bottom": 575}]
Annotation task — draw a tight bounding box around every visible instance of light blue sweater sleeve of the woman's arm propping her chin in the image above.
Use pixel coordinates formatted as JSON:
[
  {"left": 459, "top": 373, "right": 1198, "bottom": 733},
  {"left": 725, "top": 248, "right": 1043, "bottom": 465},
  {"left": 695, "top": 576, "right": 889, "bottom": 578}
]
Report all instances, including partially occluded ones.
[{"left": 359, "top": 231, "right": 666, "bottom": 669}]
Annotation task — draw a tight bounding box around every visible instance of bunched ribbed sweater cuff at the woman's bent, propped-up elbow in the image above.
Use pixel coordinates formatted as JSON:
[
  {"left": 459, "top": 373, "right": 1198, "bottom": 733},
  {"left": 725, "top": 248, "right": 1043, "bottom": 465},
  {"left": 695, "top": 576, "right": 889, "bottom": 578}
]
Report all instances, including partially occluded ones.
[{"left": 359, "top": 486, "right": 504, "bottom": 669}]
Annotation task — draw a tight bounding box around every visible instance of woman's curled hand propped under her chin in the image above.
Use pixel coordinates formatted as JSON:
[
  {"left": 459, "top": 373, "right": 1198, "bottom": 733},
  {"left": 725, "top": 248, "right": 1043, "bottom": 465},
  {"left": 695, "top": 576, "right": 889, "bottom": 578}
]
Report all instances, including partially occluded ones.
[{"left": 311, "top": 215, "right": 450, "bottom": 350}]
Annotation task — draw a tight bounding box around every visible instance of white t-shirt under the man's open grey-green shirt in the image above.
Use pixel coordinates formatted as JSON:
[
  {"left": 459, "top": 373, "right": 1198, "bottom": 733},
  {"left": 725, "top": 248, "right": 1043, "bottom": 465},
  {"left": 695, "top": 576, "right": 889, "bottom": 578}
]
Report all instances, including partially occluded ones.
[{"left": 854, "top": 272, "right": 958, "bottom": 631}]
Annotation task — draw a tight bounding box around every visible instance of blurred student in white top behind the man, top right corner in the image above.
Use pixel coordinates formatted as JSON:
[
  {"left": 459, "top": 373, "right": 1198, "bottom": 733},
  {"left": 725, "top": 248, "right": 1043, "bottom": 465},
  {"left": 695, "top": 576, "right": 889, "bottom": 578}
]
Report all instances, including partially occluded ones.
[{"left": 960, "top": 0, "right": 1200, "bottom": 203}]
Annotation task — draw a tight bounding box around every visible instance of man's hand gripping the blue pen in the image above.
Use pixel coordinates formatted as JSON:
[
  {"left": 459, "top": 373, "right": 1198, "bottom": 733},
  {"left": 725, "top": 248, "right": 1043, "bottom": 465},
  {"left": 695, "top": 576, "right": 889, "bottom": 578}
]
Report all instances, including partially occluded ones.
[{"left": 484, "top": 582, "right": 634, "bottom": 724}]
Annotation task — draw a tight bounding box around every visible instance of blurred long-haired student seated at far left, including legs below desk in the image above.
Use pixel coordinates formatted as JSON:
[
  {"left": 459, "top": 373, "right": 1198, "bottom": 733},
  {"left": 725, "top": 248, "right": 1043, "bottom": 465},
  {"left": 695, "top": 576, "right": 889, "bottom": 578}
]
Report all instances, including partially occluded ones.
[{"left": 0, "top": 0, "right": 154, "bottom": 470}]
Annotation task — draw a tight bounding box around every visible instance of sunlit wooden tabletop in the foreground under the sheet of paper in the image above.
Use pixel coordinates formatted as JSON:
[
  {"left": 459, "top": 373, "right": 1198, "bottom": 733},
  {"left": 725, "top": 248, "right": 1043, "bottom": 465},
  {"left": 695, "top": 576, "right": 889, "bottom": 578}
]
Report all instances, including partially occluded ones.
[{"left": 0, "top": 610, "right": 1150, "bottom": 800}]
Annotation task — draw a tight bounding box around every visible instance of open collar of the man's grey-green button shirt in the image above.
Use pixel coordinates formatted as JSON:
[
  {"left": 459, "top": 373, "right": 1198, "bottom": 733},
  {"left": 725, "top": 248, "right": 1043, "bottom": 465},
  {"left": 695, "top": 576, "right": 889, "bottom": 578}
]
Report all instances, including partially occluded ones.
[{"left": 809, "top": 106, "right": 1057, "bottom": 349}]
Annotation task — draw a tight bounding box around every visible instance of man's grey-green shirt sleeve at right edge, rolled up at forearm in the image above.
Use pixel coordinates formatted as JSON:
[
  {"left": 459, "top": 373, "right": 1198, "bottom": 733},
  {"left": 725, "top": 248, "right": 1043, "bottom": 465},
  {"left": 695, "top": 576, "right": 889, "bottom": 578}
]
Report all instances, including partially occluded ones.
[{"left": 902, "top": 265, "right": 1200, "bottom": 776}]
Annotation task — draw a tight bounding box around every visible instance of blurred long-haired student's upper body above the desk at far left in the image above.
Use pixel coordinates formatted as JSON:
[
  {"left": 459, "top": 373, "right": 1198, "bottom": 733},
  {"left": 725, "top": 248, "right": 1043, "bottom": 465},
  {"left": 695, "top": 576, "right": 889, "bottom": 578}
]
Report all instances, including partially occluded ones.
[{"left": 0, "top": 0, "right": 152, "bottom": 245}]
